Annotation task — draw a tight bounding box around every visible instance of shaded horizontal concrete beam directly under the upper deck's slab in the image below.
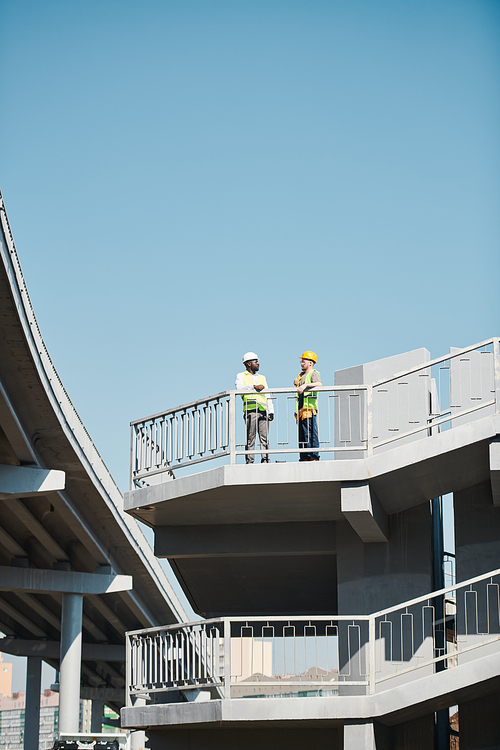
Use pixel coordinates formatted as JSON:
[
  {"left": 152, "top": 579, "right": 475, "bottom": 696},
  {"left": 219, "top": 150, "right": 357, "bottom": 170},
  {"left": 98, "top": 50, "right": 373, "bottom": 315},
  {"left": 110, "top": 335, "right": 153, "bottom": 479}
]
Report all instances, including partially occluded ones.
[{"left": 155, "top": 521, "right": 335, "bottom": 559}]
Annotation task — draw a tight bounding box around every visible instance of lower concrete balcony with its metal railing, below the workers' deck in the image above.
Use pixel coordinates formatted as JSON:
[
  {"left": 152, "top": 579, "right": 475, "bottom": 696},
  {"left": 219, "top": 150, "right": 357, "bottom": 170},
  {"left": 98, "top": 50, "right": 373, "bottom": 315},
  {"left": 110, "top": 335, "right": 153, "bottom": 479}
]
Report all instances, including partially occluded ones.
[{"left": 122, "top": 570, "right": 500, "bottom": 747}]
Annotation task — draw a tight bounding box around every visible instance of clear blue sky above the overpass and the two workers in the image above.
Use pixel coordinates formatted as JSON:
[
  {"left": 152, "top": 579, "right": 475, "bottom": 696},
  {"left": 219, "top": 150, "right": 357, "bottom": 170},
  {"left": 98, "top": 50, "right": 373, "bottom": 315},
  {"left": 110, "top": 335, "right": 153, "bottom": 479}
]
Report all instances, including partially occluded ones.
[{"left": 0, "top": 0, "right": 500, "bottom": 688}]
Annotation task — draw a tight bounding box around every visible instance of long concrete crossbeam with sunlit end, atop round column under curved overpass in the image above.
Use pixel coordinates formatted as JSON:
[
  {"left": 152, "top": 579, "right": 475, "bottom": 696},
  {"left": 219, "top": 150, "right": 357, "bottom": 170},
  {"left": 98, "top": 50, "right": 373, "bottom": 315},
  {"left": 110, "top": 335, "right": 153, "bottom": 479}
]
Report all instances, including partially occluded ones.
[{"left": 0, "top": 565, "right": 133, "bottom": 594}]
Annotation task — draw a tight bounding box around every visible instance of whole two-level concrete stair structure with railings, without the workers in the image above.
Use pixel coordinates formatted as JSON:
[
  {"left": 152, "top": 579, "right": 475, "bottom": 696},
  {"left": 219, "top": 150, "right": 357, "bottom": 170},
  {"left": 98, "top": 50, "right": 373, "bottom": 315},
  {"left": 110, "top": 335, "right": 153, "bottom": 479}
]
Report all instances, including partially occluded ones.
[{"left": 122, "top": 338, "right": 500, "bottom": 750}]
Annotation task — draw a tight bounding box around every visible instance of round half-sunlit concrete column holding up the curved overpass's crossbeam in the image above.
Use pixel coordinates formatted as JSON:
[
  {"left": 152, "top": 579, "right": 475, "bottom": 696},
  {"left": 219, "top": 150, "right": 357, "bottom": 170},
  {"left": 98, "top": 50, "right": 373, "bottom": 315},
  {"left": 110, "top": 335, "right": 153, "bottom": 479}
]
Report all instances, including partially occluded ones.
[{"left": 59, "top": 594, "right": 83, "bottom": 733}]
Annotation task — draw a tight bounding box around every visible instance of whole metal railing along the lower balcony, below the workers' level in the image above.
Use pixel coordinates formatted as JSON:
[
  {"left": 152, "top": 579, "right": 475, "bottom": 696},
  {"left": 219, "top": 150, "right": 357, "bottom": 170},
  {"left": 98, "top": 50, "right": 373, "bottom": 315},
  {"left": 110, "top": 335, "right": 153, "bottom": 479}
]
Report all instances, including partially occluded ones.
[{"left": 126, "top": 569, "right": 500, "bottom": 705}]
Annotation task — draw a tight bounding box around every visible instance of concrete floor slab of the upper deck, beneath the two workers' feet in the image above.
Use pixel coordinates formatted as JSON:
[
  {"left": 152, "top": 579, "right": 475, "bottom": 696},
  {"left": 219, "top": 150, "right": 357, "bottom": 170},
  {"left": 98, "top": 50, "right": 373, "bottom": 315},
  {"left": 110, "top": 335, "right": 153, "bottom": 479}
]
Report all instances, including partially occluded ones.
[{"left": 124, "top": 415, "right": 500, "bottom": 527}]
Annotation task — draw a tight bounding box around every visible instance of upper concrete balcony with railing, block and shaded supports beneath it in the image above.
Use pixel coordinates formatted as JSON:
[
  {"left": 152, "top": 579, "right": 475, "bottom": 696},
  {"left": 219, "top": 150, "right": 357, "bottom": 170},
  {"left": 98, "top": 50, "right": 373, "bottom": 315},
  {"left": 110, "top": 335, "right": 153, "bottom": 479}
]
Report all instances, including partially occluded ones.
[{"left": 125, "top": 339, "right": 500, "bottom": 617}]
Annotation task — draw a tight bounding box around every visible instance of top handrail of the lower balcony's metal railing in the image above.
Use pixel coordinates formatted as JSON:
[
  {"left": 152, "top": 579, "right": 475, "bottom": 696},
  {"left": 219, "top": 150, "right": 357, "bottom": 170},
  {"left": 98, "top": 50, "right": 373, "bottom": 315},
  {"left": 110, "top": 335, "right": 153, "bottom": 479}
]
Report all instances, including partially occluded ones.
[{"left": 126, "top": 568, "right": 500, "bottom": 637}]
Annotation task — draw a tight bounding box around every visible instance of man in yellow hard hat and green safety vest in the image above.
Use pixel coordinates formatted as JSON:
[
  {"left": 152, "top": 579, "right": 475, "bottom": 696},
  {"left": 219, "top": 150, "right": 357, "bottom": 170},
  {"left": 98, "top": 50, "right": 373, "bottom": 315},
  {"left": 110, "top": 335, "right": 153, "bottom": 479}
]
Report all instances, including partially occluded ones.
[{"left": 293, "top": 350, "right": 323, "bottom": 461}]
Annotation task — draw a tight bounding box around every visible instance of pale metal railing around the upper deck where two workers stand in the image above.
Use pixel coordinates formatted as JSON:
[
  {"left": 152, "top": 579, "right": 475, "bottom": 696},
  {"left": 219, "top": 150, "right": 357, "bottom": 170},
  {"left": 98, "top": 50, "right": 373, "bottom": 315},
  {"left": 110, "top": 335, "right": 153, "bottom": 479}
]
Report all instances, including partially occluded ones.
[{"left": 130, "top": 338, "right": 500, "bottom": 489}]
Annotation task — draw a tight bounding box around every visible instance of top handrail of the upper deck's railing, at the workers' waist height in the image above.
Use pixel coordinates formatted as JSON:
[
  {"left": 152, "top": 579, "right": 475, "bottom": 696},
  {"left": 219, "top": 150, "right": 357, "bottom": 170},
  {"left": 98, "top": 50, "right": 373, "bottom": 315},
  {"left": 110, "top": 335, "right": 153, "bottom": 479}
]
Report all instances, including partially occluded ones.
[{"left": 130, "top": 336, "right": 500, "bottom": 427}]
